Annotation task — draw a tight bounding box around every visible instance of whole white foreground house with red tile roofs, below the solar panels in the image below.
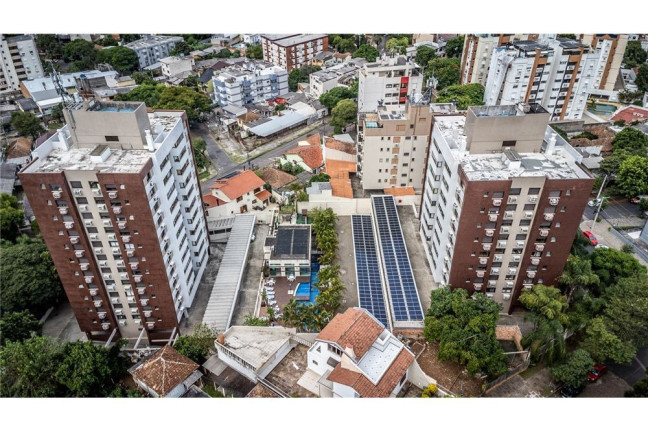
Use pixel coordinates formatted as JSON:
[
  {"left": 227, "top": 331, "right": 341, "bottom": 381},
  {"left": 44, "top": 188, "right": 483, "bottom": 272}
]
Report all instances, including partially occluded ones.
[{"left": 302, "top": 307, "right": 434, "bottom": 398}]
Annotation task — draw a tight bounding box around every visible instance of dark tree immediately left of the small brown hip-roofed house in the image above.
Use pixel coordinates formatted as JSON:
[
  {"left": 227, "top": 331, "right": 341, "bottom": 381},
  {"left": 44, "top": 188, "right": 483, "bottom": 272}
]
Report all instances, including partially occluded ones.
[{"left": 56, "top": 341, "right": 128, "bottom": 397}]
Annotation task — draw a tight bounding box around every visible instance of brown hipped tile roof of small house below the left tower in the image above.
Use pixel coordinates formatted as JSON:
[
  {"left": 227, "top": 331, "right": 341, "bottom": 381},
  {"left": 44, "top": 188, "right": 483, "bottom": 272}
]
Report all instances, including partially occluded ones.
[{"left": 131, "top": 345, "right": 199, "bottom": 397}]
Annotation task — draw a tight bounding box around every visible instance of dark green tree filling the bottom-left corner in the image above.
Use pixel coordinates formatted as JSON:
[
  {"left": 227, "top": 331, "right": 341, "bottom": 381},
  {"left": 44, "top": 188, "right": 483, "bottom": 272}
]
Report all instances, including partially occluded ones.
[{"left": 0, "top": 336, "right": 63, "bottom": 397}]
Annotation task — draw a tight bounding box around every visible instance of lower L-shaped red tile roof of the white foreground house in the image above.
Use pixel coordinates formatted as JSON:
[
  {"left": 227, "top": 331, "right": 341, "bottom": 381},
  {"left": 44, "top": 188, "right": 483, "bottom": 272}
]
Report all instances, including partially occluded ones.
[{"left": 328, "top": 348, "right": 414, "bottom": 398}]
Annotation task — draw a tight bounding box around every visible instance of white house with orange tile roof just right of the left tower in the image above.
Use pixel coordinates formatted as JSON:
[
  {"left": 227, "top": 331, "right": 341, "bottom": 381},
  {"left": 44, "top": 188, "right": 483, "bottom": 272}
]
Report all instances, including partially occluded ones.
[{"left": 203, "top": 170, "right": 272, "bottom": 217}]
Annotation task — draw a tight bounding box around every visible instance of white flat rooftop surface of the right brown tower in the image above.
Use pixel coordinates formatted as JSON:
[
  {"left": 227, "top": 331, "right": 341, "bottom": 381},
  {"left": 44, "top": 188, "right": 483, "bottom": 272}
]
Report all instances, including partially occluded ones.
[{"left": 435, "top": 116, "right": 590, "bottom": 180}]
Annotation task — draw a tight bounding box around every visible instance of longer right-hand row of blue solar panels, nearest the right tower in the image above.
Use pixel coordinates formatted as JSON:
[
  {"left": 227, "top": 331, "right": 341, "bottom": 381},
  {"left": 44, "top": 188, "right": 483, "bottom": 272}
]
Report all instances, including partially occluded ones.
[{"left": 371, "top": 195, "right": 423, "bottom": 321}]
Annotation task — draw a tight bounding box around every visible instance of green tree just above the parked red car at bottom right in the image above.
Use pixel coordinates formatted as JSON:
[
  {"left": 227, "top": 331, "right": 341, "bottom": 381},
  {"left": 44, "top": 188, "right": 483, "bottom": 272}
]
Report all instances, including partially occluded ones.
[{"left": 581, "top": 317, "right": 637, "bottom": 364}]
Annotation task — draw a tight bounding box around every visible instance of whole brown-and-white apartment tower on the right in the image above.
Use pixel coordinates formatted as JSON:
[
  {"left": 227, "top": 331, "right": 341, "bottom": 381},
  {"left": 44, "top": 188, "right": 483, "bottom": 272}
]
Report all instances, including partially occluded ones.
[{"left": 419, "top": 104, "right": 594, "bottom": 313}]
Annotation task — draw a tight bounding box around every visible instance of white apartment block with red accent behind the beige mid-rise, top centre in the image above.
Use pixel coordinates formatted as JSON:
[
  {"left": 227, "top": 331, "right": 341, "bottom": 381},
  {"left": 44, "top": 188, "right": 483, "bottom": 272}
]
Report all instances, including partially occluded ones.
[{"left": 358, "top": 56, "right": 423, "bottom": 112}]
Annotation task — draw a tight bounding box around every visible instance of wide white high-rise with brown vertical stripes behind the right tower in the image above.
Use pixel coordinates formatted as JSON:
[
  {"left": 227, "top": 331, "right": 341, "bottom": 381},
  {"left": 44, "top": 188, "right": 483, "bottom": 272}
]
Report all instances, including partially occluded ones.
[{"left": 484, "top": 38, "right": 607, "bottom": 120}]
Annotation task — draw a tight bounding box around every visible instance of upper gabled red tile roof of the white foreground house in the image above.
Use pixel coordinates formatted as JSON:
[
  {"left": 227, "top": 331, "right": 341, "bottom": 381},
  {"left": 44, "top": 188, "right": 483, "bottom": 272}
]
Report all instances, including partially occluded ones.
[{"left": 317, "top": 308, "right": 385, "bottom": 360}]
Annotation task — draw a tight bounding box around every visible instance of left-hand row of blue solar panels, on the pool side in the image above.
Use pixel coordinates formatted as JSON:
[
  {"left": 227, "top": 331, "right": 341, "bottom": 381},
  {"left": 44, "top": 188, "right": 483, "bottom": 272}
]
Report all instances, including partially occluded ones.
[{"left": 351, "top": 215, "right": 389, "bottom": 327}]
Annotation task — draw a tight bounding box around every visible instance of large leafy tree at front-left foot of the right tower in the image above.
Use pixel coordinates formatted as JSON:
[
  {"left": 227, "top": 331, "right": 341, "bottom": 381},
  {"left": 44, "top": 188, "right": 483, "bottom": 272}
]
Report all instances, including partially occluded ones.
[{"left": 423, "top": 286, "right": 506, "bottom": 376}]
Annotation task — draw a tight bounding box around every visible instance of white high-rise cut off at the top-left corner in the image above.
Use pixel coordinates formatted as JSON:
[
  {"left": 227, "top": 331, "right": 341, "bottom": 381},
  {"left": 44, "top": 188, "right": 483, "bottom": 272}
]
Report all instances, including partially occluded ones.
[{"left": 0, "top": 34, "right": 44, "bottom": 94}]
